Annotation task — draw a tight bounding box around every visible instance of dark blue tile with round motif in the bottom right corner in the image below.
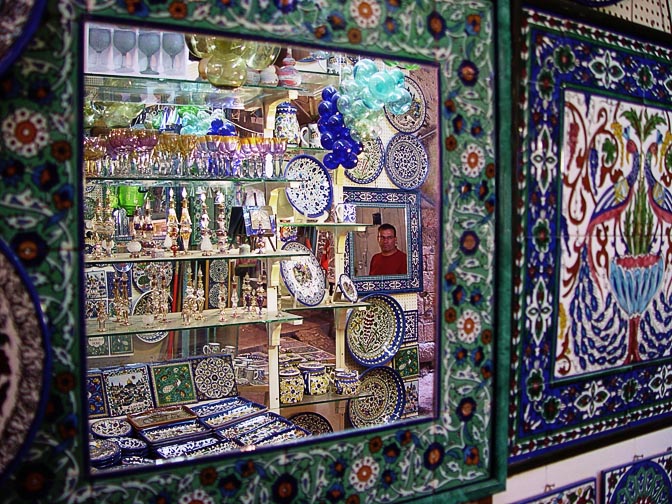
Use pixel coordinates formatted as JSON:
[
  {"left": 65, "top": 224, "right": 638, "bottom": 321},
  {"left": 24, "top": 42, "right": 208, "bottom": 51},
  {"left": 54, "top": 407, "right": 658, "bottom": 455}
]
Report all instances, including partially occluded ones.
[{"left": 602, "top": 453, "right": 672, "bottom": 504}]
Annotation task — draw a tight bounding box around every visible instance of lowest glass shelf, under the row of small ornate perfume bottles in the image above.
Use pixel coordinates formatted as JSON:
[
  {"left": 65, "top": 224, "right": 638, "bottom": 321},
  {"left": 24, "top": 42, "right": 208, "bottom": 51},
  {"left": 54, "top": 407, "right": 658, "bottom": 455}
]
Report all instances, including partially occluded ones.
[{"left": 86, "top": 307, "right": 303, "bottom": 338}]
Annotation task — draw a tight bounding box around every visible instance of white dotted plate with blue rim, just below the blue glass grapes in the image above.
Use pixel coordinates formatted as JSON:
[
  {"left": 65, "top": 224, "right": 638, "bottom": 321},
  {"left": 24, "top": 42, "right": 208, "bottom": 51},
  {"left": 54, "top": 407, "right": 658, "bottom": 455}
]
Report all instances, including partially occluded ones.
[{"left": 285, "top": 154, "right": 334, "bottom": 218}]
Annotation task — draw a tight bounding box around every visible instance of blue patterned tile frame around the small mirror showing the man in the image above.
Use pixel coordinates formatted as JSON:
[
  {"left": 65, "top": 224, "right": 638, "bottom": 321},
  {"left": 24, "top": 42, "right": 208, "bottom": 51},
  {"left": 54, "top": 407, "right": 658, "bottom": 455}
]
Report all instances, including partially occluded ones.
[{"left": 343, "top": 187, "right": 423, "bottom": 295}]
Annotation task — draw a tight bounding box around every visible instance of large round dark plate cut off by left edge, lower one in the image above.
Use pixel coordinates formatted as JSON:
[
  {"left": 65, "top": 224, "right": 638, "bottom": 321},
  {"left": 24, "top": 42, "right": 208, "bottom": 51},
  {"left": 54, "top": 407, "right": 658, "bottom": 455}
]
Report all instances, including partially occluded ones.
[{"left": 0, "top": 240, "right": 51, "bottom": 479}]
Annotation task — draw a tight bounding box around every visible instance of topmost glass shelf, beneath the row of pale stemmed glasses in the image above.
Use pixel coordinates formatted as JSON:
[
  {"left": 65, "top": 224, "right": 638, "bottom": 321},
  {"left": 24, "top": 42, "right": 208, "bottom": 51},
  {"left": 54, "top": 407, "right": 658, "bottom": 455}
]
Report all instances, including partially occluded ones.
[{"left": 84, "top": 72, "right": 338, "bottom": 109}]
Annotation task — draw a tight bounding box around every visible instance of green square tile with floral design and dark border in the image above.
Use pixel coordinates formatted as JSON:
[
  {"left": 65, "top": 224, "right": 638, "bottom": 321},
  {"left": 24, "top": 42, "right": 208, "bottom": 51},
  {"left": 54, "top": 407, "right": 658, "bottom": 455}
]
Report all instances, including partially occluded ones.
[{"left": 150, "top": 361, "right": 196, "bottom": 407}]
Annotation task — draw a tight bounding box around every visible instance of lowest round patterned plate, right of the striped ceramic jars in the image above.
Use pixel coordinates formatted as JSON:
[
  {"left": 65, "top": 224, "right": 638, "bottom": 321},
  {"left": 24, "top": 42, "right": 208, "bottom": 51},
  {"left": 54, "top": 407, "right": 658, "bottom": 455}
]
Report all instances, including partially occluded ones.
[{"left": 348, "top": 366, "right": 406, "bottom": 428}]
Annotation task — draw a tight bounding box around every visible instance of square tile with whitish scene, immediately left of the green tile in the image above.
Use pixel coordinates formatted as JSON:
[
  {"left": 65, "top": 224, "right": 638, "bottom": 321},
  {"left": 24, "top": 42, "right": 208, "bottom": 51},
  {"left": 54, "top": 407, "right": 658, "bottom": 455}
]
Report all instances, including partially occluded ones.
[{"left": 103, "top": 365, "right": 154, "bottom": 416}]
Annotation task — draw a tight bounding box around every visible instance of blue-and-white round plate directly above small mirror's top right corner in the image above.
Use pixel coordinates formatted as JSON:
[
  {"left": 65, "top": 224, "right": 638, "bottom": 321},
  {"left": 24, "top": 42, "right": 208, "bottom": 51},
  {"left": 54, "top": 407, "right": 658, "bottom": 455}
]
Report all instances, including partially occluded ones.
[{"left": 385, "top": 133, "right": 429, "bottom": 189}]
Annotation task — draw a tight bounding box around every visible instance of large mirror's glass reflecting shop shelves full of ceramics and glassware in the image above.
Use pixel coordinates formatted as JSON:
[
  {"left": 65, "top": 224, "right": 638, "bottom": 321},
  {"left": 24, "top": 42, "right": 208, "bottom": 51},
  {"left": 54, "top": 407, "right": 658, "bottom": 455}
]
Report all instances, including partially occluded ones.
[{"left": 81, "top": 23, "right": 440, "bottom": 471}]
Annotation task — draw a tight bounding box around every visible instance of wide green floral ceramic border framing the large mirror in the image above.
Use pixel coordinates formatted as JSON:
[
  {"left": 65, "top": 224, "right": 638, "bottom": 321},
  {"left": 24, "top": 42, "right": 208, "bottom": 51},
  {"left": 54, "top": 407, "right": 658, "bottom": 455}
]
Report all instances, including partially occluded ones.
[{"left": 0, "top": 0, "right": 512, "bottom": 504}]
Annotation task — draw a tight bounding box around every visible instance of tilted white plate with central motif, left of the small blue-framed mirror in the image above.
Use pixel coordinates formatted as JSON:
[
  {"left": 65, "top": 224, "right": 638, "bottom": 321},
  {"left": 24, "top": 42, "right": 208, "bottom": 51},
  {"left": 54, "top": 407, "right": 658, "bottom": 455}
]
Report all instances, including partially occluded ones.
[{"left": 280, "top": 242, "right": 324, "bottom": 306}]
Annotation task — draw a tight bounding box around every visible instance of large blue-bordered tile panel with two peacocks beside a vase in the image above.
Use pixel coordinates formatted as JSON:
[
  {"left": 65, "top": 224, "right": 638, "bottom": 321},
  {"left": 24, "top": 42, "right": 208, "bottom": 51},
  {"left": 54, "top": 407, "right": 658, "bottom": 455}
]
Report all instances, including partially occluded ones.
[{"left": 510, "top": 5, "right": 672, "bottom": 461}]
